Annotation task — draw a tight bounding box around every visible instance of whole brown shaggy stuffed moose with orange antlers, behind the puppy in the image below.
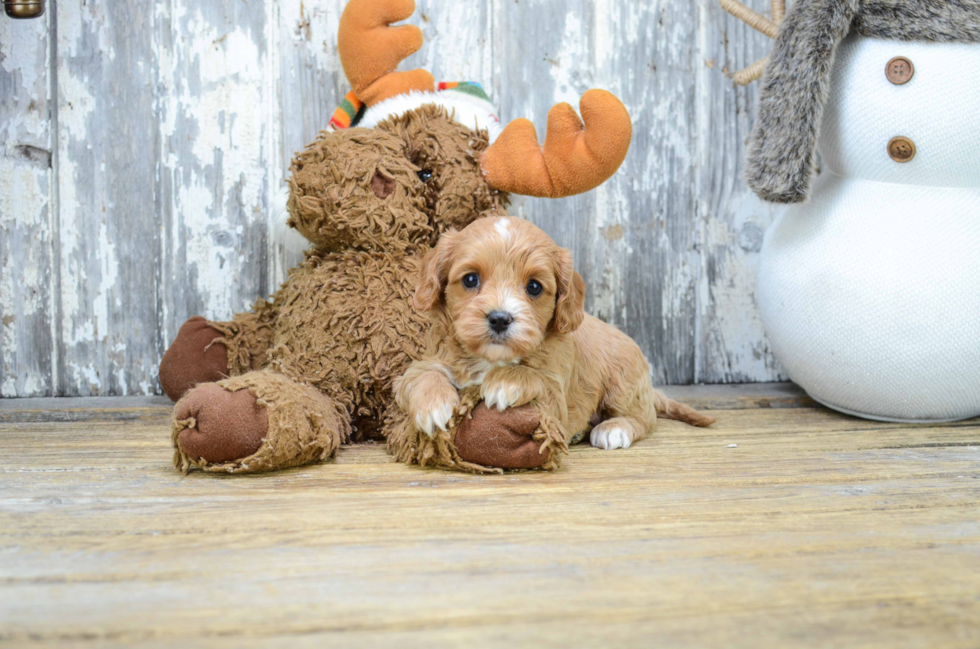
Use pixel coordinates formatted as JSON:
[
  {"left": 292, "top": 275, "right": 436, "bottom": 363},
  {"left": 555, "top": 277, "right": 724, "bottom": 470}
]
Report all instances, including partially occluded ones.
[{"left": 160, "top": 0, "right": 631, "bottom": 473}]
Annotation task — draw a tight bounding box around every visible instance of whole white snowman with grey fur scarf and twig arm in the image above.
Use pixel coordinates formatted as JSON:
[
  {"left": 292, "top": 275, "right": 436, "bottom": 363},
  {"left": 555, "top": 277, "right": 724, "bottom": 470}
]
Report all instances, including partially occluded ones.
[{"left": 722, "top": 0, "right": 980, "bottom": 422}]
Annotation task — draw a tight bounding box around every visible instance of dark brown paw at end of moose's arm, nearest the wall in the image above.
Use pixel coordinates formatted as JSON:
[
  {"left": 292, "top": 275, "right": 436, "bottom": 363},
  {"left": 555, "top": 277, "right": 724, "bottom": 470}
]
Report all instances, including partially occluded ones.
[{"left": 160, "top": 315, "right": 228, "bottom": 401}]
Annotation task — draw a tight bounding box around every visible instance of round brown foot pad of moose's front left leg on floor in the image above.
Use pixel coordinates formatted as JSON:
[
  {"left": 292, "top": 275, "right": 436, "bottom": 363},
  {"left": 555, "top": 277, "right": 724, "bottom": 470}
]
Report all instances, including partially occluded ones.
[{"left": 174, "top": 383, "right": 269, "bottom": 464}]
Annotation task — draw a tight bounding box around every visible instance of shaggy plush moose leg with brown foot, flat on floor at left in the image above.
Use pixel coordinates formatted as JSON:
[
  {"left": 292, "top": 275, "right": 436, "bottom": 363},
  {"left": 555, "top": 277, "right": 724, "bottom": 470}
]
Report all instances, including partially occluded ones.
[{"left": 173, "top": 370, "right": 350, "bottom": 473}]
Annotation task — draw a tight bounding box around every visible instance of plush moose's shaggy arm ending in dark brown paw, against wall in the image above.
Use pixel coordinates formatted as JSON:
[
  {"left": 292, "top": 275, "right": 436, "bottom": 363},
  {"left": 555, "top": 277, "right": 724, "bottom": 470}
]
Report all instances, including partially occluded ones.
[{"left": 160, "top": 300, "right": 275, "bottom": 401}]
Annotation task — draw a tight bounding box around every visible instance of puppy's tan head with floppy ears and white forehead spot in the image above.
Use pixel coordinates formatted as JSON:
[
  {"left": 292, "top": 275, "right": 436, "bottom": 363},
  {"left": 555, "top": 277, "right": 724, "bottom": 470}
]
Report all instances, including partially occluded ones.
[{"left": 415, "top": 217, "right": 585, "bottom": 362}]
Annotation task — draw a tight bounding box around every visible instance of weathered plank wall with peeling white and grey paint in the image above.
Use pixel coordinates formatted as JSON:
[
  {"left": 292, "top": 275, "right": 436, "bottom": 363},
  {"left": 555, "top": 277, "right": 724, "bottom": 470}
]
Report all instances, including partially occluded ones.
[{"left": 0, "top": 0, "right": 784, "bottom": 396}]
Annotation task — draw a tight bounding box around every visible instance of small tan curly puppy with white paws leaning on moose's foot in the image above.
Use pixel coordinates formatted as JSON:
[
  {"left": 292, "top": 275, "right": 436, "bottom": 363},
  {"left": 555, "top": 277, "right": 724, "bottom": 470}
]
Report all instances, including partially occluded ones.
[{"left": 395, "top": 217, "right": 715, "bottom": 450}]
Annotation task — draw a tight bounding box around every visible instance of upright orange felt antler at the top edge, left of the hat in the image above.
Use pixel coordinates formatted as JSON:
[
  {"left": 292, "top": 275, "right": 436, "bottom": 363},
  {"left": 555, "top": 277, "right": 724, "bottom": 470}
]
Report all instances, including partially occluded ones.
[{"left": 337, "top": 0, "right": 435, "bottom": 106}]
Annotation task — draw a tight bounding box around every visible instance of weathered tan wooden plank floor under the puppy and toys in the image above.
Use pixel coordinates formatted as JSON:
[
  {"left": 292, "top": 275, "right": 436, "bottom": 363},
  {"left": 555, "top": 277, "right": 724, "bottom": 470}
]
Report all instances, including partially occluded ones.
[{"left": 0, "top": 385, "right": 980, "bottom": 648}]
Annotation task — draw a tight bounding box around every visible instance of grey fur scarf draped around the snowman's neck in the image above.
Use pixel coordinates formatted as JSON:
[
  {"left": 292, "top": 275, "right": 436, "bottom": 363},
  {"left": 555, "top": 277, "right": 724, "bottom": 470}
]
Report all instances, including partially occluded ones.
[{"left": 745, "top": 0, "right": 980, "bottom": 203}]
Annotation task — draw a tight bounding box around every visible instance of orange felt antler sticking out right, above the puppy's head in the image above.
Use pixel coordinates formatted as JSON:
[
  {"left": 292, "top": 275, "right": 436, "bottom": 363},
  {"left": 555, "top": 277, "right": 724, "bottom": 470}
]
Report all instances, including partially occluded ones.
[{"left": 480, "top": 90, "right": 633, "bottom": 198}]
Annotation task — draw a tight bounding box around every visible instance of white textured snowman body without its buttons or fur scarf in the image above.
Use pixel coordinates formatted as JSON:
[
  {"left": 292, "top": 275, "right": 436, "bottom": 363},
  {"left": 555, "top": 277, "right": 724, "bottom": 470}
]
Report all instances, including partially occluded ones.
[{"left": 758, "top": 36, "right": 980, "bottom": 421}]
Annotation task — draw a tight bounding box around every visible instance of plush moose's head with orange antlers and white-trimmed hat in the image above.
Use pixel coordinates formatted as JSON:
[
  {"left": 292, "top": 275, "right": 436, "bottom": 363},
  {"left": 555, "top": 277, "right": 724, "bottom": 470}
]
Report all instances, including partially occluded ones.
[{"left": 289, "top": 0, "right": 632, "bottom": 251}]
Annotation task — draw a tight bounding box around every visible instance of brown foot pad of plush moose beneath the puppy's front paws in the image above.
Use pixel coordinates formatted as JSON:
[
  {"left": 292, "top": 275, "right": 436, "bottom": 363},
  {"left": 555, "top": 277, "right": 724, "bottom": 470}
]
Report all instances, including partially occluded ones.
[{"left": 455, "top": 403, "right": 552, "bottom": 469}]
